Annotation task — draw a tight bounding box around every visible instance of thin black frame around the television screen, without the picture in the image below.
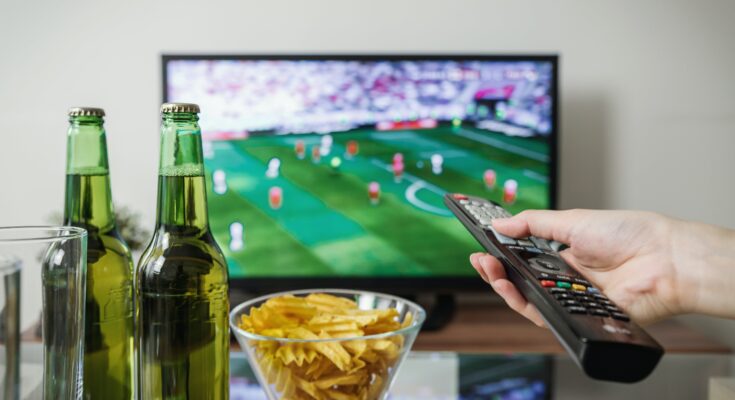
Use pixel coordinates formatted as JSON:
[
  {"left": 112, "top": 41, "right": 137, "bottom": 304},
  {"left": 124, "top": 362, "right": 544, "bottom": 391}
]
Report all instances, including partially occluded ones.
[{"left": 161, "top": 53, "right": 560, "bottom": 294}]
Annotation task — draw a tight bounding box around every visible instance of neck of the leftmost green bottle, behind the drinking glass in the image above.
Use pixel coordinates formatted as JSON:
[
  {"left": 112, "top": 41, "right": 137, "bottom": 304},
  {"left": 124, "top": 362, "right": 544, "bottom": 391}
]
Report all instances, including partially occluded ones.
[{"left": 64, "top": 116, "right": 115, "bottom": 231}]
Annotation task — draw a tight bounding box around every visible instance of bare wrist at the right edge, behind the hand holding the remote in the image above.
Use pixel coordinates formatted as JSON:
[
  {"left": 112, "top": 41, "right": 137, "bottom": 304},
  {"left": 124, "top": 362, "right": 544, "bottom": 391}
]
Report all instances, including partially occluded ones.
[{"left": 671, "top": 221, "right": 735, "bottom": 318}]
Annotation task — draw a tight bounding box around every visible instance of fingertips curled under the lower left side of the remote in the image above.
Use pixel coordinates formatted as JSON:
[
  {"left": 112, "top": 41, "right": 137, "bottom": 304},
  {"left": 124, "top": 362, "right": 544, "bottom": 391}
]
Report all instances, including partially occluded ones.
[{"left": 470, "top": 253, "right": 545, "bottom": 326}]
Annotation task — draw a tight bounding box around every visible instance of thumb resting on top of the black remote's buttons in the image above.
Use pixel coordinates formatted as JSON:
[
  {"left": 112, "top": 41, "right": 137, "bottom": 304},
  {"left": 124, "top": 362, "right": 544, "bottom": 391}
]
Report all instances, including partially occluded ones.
[{"left": 493, "top": 210, "right": 586, "bottom": 243}]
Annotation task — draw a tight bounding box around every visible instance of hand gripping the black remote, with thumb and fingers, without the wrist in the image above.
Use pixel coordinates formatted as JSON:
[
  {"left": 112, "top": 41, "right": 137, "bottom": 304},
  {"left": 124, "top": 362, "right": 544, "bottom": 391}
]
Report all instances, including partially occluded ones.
[{"left": 470, "top": 210, "right": 694, "bottom": 326}]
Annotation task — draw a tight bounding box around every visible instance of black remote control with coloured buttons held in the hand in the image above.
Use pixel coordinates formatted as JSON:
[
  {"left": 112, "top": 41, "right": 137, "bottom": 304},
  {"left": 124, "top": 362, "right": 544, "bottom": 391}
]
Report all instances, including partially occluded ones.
[{"left": 444, "top": 193, "right": 664, "bottom": 383}]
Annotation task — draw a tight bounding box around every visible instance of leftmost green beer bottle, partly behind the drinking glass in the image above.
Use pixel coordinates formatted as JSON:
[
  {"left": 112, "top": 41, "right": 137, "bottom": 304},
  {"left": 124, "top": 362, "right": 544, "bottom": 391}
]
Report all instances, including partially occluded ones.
[{"left": 64, "top": 107, "right": 133, "bottom": 400}]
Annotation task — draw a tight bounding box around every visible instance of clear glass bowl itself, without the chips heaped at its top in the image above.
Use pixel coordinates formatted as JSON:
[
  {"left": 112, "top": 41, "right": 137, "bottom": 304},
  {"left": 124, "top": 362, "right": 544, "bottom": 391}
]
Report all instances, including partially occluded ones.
[{"left": 230, "top": 289, "right": 426, "bottom": 400}]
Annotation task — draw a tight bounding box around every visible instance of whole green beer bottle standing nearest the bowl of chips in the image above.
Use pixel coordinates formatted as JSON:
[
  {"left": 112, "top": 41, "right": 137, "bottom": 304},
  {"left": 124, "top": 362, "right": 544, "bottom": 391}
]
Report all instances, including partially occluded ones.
[{"left": 135, "top": 104, "right": 229, "bottom": 400}]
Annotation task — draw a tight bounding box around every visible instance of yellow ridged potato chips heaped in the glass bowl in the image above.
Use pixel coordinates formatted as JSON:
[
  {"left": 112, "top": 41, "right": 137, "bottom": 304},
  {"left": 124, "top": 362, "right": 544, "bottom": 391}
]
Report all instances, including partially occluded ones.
[{"left": 239, "top": 293, "right": 413, "bottom": 400}]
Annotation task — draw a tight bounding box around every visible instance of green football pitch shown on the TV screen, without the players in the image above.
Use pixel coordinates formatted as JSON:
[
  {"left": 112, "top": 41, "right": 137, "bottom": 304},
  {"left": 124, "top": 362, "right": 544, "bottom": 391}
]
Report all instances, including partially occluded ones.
[{"left": 205, "top": 127, "right": 549, "bottom": 278}]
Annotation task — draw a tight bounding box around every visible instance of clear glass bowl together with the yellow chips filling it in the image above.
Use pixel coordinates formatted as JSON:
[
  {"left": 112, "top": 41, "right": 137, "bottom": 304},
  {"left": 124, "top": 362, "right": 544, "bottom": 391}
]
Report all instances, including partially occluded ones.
[{"left": 230, "top": 289, "right": 426, "bottom": 400}]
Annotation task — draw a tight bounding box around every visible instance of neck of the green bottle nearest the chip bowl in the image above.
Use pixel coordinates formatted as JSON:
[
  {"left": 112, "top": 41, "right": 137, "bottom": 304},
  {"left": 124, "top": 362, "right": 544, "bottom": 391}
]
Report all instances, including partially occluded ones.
[{"left": 156, "top": 113, "right": 209, "bottom": 233}]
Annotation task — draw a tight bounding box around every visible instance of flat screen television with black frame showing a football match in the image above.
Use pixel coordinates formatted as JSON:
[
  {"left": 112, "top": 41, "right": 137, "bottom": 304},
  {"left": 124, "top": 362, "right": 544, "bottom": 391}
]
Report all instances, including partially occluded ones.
[{"left": 162, "top": 55, "right": 559, "bottom": 292}]
